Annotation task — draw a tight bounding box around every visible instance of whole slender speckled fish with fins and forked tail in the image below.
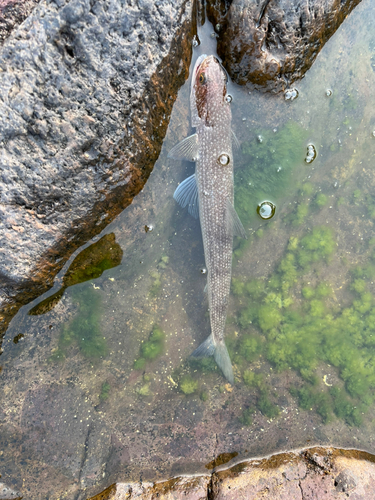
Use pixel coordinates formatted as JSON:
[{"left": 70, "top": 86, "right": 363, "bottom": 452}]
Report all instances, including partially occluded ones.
[{"left": 168, "top": 54, "right": 246, "bottom": 385}]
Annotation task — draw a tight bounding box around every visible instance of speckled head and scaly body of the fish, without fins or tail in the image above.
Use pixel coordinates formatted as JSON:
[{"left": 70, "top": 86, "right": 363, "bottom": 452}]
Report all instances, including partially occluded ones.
[{"left": 193, "top": 56, "right": 233, "bottom": 352}]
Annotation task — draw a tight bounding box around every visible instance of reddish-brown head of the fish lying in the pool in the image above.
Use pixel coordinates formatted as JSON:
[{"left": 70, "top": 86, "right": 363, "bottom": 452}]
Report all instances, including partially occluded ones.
[{"left": 190, "top": 54, "right": 229, "bottom": 127}]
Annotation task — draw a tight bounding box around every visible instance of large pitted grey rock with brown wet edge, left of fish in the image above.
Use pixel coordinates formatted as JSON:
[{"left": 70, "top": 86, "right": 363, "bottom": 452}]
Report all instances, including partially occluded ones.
[{"left": 0, "top": 0, "right": 192, "bottom": 336}]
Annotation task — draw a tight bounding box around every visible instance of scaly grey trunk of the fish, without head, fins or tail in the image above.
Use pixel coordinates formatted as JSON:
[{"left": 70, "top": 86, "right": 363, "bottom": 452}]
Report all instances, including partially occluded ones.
[{"left": 195, "top": 117, "right": 233, "bottom": 341}]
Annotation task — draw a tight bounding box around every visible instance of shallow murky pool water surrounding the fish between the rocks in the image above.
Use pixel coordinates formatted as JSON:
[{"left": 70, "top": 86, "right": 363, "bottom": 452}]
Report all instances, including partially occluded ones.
[{"left": 0, "top": 0, "right": 375, "bottom": 498}]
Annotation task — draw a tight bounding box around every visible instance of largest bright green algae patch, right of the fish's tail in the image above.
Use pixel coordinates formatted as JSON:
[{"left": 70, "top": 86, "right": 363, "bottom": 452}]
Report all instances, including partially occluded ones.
[{"left": 228, "top": 226, "right": 375, "bottom": 426}]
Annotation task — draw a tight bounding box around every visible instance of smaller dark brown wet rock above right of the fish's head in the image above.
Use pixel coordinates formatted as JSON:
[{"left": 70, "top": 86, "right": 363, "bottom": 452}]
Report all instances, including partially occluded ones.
[{"left": 208, "top": 0, "right": 361, "bottom": 92}]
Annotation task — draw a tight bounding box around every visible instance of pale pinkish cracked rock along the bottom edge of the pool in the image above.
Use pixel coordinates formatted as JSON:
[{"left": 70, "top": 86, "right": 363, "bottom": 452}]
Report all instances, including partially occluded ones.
[{"left": 91, "top": 448, "right": 375, "bottom": 500}]
